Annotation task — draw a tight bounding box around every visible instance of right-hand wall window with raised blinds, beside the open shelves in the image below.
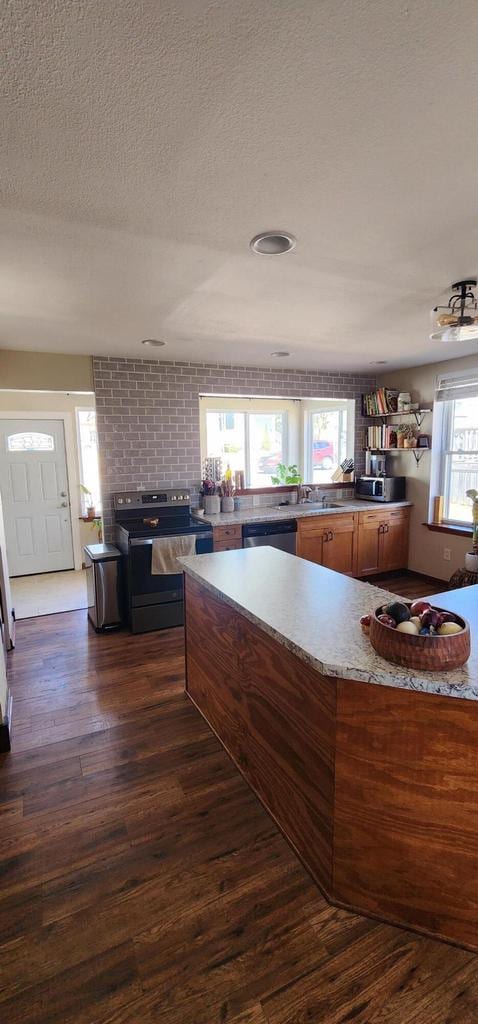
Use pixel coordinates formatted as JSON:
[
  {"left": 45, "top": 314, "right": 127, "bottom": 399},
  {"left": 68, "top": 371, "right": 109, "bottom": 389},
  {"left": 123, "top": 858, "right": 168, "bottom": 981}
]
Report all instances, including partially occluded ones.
[{"left": 436, "top": 370, "right": 478, "bottom": 525}]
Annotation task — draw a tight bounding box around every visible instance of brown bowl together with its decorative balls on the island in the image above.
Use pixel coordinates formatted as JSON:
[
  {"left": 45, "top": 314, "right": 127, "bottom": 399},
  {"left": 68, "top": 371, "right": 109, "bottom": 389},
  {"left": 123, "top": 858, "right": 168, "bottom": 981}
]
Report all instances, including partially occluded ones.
[{"left": 361, "top": 601, "right": 471, "bottom": 672}]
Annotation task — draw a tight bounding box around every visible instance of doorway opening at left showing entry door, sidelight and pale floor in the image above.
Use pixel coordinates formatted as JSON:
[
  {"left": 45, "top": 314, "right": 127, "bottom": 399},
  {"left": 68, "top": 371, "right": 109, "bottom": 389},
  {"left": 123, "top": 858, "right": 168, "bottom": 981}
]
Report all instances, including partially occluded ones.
[{"left": 0, "top": 391, "right": 102, "bottom": 618}]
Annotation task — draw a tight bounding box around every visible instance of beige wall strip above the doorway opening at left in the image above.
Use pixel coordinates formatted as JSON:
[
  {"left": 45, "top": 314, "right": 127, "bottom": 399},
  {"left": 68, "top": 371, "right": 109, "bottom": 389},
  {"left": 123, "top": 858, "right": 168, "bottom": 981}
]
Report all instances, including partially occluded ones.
[{"left": 0, "top": 348, "right": 93, "bottom": 391}]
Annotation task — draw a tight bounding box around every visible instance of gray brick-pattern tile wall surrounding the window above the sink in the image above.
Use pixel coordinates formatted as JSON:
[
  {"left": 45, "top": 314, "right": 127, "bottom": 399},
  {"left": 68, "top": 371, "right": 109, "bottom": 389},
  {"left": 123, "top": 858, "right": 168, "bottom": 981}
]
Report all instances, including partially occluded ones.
[{"left": 93, "top": 357, "right": 376, "bottom": 540}]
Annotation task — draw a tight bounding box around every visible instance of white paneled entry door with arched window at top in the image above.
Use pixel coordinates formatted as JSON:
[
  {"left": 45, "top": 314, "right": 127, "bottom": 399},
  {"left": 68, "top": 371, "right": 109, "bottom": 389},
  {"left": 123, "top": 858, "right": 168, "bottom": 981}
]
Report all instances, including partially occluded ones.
[{"left": 0, "top": 419, "right": 74, "bottom": 575}]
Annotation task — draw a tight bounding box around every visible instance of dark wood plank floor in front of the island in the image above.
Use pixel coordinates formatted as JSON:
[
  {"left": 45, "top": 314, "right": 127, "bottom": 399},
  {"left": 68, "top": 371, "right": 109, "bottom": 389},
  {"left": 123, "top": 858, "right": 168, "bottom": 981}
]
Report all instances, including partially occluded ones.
[{"left": 0, "top": 611, "right": 478, "bottom": 1024}]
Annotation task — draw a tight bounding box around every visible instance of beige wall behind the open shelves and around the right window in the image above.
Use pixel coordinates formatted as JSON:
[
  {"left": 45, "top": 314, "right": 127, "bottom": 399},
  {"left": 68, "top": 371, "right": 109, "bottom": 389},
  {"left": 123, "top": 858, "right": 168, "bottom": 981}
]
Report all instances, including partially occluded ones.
[{"left": 378, "top": 355, "right": 478, "bottom": 580}]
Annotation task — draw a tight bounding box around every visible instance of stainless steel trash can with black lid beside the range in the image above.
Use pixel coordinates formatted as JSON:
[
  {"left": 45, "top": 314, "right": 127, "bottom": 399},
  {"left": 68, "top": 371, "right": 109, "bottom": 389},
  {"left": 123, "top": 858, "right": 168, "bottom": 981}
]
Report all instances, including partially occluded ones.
[{"left": 83, "top": 544, "right": 123, "bottom": 633}]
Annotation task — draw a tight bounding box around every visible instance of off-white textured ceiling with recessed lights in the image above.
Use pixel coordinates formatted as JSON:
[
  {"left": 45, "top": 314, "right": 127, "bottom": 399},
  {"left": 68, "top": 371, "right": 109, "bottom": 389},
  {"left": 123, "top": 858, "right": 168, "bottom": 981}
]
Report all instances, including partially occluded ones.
[{"left": 0, "top": 0, "right": 478, "bottom": 369}]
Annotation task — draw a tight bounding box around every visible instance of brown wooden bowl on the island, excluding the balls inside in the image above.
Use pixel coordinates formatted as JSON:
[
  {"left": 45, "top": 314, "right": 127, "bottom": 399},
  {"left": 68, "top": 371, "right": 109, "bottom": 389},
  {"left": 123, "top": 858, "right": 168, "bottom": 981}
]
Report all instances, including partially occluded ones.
[{"left": 370, "top": 601, "right": 471, "bottom": 672}]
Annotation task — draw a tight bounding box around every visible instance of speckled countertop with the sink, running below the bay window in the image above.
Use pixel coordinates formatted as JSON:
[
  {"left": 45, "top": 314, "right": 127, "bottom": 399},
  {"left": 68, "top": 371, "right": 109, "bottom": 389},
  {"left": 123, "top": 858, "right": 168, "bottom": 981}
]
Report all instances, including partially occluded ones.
[{"left": 192, "top": 498, "right": 411, "bottom": 526}]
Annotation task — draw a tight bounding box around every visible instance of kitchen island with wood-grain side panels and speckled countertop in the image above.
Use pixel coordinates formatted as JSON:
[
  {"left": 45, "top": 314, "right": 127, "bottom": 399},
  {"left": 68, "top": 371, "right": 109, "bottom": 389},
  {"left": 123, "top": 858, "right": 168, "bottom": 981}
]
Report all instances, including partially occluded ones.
[{"left": 183, "top": 548, "right": 478, "bottom": 949}]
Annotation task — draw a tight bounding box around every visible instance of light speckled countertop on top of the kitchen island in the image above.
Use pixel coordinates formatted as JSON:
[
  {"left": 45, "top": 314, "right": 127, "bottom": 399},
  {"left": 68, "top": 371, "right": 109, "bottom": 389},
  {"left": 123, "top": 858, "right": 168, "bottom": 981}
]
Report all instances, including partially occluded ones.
[{"left": 179, "top": 547, "right": 478, "bottom": 700}]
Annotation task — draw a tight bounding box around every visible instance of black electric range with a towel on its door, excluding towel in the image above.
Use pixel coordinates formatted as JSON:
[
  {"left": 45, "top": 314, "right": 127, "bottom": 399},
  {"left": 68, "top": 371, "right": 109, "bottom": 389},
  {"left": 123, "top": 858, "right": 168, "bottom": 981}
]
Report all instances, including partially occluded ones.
[{"left": 114, "top": 489, "right": 213, "bottom": 633}]
